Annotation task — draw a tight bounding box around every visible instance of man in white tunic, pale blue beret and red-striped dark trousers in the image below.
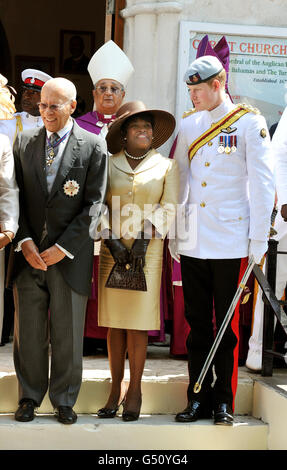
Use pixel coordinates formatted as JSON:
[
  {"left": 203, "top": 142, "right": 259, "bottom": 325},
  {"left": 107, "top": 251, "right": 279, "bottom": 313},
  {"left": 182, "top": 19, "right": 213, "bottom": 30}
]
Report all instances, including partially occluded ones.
[{"left": 170, "top": 56, "right": 275, "bottom": 425}]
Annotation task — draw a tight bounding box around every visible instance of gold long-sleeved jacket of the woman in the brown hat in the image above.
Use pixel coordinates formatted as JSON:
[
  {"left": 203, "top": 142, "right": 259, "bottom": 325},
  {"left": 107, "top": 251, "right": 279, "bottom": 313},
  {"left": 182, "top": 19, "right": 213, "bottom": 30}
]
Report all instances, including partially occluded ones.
[{"left": 102, "top": 150, "right": 179, "bottom": 239}]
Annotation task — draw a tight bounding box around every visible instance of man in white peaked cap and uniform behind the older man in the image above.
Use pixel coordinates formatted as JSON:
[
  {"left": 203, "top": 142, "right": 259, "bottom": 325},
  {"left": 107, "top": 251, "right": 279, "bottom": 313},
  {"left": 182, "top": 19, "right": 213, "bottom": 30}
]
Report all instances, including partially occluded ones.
[{"left": 0, "top": 69, "right": 52, "bottom": 146}]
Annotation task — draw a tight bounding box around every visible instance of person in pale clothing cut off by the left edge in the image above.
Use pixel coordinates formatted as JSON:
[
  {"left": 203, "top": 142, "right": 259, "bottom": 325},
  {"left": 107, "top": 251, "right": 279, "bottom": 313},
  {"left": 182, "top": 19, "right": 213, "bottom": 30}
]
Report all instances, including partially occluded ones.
[{"left": 0, "top": 75, "right": 19, "bottom": 338}]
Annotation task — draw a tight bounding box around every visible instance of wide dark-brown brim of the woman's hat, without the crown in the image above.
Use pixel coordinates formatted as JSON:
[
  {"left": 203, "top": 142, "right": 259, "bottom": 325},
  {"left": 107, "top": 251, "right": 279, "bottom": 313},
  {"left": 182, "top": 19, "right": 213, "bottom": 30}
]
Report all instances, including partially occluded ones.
[{"left": 106, "top": 109, "right": 176, "bottom": 154}]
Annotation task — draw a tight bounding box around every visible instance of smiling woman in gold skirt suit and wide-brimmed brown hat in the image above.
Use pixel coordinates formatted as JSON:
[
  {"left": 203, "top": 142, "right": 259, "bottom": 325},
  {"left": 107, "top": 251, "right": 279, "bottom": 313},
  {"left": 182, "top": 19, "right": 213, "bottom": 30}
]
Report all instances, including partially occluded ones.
[{"left": 98, "top": 101, "right": 178, "bottom": 421}]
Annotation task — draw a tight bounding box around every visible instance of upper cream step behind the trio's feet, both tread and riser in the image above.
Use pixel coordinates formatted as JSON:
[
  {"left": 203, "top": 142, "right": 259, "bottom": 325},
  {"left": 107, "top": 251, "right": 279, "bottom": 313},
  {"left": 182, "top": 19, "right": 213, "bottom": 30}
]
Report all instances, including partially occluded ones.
[{"left": 0, "top": 343, "right": 254, "bottom": 415}]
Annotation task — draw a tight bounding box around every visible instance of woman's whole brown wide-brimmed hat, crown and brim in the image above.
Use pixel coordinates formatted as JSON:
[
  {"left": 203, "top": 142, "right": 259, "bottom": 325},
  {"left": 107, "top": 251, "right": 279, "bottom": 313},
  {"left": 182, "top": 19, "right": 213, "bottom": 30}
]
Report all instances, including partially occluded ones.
[{"left": 106, "top": 101, "right": 175, "bottom": 153}]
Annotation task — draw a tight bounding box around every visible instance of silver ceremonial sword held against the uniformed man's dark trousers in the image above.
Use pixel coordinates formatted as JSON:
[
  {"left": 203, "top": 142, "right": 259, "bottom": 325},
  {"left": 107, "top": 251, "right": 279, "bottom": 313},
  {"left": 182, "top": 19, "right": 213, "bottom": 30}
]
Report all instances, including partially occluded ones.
[{"left": 193, "top": 256, "right": 255, "bottom": 393}]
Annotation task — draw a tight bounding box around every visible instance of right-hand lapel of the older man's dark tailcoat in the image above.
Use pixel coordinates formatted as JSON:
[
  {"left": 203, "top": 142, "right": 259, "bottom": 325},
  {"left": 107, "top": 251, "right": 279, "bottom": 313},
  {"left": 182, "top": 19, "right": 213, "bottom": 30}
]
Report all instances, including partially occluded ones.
[{"left": 49, "top": 122, "right": 84, "bottom": 199}]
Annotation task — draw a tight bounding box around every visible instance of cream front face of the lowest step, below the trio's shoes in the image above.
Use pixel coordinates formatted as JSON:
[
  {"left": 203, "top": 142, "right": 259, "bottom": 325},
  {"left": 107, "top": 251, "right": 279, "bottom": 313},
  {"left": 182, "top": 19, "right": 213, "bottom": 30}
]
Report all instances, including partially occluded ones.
[{"left": 0, "top": 414, "right": 268, "bottom": 451}]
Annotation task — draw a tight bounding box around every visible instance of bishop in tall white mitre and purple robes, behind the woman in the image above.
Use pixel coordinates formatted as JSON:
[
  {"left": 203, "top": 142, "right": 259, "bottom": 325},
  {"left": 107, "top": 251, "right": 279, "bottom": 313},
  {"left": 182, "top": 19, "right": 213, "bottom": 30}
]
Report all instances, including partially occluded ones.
[{"left": 76, "top": 41, "right": 134, "bottom": 356}]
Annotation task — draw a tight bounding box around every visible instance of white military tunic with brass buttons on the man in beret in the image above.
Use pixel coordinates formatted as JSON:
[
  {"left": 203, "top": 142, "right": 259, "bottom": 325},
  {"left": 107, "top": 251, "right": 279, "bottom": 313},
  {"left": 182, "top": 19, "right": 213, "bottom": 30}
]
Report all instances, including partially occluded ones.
[{"left": 174, "top": 96, "right": 275, "bottom": 259}]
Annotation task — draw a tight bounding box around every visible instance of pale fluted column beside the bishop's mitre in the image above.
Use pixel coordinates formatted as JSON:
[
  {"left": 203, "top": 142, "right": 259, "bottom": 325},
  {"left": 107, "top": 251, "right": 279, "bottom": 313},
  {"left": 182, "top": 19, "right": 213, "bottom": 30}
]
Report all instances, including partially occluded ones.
[{"left": 121, "top": 1, "right": 182, "bottom": 109}]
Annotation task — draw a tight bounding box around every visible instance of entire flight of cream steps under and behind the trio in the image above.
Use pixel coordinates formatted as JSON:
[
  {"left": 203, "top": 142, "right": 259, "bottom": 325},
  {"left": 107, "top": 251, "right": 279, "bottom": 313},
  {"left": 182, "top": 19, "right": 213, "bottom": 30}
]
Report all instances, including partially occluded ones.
[{"left": 0, "top": 344, "right": 287, "bottom": 450}]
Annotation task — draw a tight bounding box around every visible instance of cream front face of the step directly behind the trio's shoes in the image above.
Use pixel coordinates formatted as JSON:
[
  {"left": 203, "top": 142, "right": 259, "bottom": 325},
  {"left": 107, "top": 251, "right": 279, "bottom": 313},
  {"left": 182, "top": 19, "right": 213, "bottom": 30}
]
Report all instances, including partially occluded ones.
[{"left": 0, "top": 370, "right": 253, "bottom": 415}]
